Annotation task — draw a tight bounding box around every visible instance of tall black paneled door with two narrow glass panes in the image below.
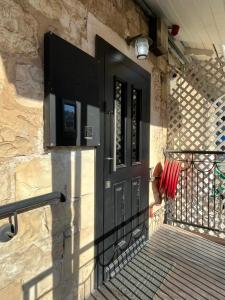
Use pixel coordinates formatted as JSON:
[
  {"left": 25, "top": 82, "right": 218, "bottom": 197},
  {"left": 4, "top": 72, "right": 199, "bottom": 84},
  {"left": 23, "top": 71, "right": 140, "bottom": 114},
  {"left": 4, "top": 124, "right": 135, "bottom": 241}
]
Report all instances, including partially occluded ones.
[{"left": 96, "top": 37, "right": 150, "bottom": 284}]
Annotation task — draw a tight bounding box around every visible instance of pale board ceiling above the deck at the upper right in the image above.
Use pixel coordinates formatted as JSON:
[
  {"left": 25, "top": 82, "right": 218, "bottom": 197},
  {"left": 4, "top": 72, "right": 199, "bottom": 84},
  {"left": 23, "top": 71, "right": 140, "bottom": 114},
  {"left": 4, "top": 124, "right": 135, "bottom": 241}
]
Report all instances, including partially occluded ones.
[{"left": 145, "top": 0, "right": 225, "bottom": 55}]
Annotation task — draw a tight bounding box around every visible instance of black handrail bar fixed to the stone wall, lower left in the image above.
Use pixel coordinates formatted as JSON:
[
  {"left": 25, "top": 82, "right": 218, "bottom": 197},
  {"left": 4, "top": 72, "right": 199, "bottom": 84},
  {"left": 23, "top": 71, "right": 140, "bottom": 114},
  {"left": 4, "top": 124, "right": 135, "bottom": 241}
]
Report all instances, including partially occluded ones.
[{"left": 0, "top": 192, "right": 66, "bottom": 220}]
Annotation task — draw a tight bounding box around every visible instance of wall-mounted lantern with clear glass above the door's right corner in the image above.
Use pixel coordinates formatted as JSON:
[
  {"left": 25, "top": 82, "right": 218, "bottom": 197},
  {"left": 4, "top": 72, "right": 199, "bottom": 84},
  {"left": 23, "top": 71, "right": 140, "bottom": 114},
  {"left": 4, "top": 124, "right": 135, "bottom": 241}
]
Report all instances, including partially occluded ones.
[{"left": 126, "top": 34, "right": 153, "bottom": 59}]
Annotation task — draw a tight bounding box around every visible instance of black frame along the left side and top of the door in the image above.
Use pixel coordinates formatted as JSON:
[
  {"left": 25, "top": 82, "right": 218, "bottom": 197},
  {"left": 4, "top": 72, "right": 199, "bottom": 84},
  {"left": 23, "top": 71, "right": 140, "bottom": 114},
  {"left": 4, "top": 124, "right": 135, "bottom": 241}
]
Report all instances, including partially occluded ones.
[{"left": 94, "top": 35, "right": 151, "bottom": 287}]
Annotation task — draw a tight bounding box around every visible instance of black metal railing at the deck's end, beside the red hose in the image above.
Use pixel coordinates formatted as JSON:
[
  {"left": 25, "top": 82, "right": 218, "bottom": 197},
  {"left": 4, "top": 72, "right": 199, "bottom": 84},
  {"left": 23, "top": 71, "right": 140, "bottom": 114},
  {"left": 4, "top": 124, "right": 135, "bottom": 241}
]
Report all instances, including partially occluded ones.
[{"left": 164, "top": 150, "right": 225, "bottom": 233}]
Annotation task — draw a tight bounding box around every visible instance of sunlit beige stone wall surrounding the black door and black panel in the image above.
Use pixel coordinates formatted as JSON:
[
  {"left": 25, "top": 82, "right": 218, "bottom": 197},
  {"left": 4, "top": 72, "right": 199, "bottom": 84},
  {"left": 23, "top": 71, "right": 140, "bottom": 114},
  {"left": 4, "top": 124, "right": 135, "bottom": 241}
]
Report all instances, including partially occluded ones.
[{"left": 0, "top": 0, "right": 166, "bottom": 300}]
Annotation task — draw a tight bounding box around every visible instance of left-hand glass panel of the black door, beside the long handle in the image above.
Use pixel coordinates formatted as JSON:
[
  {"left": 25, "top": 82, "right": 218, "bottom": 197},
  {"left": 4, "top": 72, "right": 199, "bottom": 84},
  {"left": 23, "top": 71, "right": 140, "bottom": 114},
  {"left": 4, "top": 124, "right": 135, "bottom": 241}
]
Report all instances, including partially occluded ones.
[{"left": 114, "top": 79, "right": 126, "bottom": 166}]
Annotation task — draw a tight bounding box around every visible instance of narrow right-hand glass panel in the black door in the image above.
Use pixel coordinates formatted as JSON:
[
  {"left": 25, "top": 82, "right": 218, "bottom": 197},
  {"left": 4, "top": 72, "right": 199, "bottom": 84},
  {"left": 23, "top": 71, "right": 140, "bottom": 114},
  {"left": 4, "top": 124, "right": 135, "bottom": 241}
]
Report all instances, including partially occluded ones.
[{"left": 131, "top": 88, "right": 141, "bottom": 162}]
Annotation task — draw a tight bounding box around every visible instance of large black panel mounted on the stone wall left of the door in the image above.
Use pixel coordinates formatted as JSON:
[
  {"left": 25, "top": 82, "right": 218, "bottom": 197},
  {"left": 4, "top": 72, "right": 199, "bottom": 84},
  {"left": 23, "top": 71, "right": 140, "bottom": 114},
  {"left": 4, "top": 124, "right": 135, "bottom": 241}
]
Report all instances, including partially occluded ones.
[{"left": 44, "top": 32, "right": 100, "bottom": 146}]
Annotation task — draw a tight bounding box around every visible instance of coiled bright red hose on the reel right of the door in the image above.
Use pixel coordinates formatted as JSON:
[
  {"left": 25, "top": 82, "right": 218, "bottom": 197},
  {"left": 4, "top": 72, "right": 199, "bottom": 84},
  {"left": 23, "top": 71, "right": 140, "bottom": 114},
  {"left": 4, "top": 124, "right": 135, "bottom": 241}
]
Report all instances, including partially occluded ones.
[{"left": 159, "top": 160, "right": 181, "bottom": 199}]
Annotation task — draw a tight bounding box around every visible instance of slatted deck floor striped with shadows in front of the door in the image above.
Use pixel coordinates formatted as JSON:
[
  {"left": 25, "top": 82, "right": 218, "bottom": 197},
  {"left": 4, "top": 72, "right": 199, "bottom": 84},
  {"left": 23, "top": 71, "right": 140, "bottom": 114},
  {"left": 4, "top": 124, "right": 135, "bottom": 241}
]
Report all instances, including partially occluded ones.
[{"left": 90, "top": 225, "right": 225, "bottom": 300}]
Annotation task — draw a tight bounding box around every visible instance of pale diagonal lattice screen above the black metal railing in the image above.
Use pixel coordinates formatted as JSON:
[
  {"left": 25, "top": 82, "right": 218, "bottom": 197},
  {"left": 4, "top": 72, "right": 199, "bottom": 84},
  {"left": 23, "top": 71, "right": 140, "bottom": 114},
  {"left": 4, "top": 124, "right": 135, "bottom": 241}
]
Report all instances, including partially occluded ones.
[{"left": 168, "top": 57, "right": 225, "bottom": 150}]
